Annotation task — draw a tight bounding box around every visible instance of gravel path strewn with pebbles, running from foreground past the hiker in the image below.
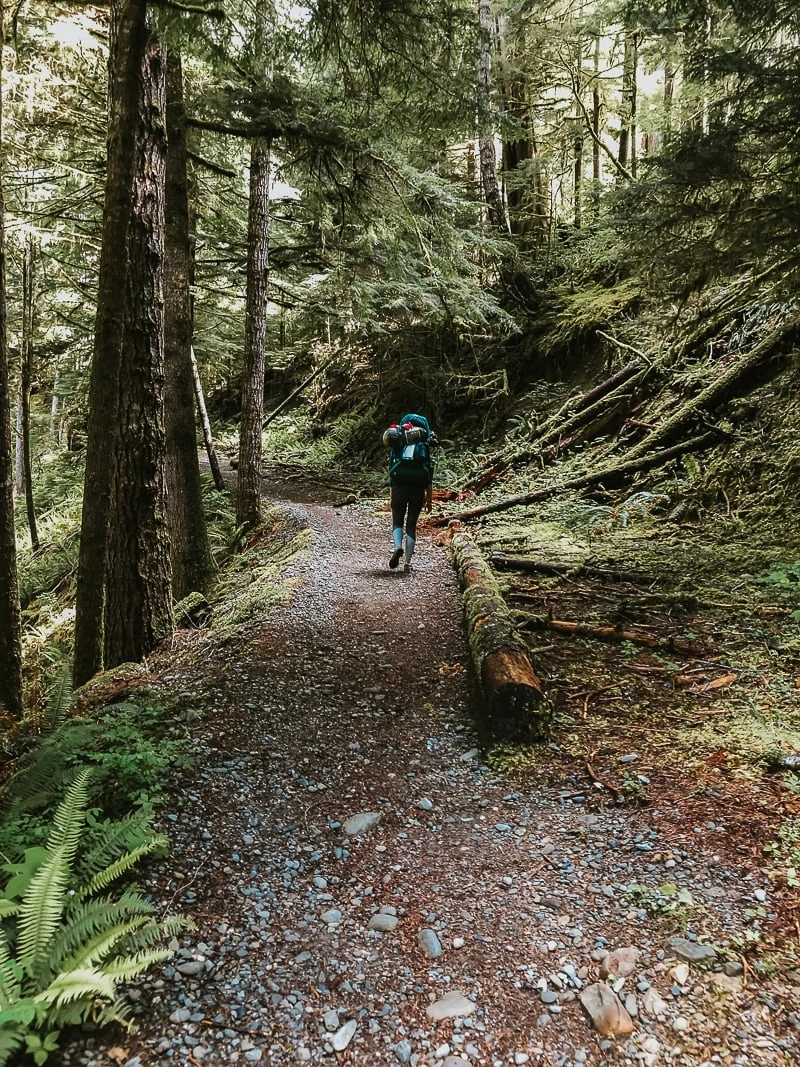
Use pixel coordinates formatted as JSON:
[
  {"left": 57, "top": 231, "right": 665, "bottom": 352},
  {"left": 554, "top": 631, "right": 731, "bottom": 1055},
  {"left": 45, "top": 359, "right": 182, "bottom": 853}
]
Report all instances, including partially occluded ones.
[{"left": 65, "top": 482, "right": 800, "bottom": 1067}]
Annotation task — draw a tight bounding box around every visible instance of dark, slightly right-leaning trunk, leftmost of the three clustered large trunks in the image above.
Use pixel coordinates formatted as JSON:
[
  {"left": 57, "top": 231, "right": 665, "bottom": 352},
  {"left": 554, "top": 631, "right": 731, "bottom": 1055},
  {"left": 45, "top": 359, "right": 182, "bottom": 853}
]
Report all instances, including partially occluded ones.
[{"left": 73, "top": 0, "right": 147, "bottom": 685}]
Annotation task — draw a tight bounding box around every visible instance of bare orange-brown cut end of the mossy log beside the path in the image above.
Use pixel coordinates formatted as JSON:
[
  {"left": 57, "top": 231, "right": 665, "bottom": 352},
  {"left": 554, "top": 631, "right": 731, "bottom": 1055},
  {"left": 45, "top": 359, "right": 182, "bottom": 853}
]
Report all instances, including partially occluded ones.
[{"left": 481, "top": 649, "right": 553, "bottom": 744}]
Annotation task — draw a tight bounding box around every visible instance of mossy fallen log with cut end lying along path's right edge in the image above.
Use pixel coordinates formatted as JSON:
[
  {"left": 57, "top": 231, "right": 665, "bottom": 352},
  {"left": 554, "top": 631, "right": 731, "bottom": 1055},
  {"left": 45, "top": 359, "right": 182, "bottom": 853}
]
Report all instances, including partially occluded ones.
[{"left": 450, "top": 530, "right": 553, "bottom": 743}]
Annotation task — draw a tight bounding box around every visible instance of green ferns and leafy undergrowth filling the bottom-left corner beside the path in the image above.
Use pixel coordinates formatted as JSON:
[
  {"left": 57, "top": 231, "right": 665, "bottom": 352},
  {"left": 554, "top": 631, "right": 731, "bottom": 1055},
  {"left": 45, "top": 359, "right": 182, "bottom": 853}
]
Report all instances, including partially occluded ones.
[{"left": 0, "top": 669, "right": 196, "bottom": 1067}]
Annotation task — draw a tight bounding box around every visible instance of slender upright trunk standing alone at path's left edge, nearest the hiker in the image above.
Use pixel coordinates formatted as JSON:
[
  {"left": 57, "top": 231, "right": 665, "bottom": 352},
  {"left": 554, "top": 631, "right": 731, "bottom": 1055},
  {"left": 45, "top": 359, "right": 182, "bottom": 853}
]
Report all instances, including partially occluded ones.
[{"left": 236, "top": 138, "right": 270, "bottom": 527}]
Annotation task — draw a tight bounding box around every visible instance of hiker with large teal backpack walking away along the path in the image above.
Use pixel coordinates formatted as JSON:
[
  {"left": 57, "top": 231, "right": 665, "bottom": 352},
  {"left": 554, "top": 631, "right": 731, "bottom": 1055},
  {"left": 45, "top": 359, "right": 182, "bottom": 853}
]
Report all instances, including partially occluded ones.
[{"left": 383, "top": 414, "right": 436, "bottom": 574}]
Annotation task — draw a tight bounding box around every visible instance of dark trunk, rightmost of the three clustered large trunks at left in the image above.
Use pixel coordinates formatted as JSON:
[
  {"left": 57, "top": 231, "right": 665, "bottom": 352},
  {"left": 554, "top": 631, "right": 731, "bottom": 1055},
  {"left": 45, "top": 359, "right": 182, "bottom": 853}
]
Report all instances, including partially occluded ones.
[{"left": 164, "top": 49, "right": 213, "bottom": 601}]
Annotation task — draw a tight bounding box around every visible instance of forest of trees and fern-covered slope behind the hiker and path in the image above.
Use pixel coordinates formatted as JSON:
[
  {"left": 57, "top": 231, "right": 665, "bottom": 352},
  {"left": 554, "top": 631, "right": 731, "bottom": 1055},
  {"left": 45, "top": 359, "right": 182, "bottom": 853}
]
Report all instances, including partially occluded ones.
[{"left": 0, "top": 0, "right": 800, "bottom": 1058}]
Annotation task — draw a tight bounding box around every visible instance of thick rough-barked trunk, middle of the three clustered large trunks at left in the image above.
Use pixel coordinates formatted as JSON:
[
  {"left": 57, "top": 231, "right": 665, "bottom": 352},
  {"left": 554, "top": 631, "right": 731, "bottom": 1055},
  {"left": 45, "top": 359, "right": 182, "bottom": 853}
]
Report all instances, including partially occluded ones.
[{"left": 105, "top": 38, "right": 173, "bottom": 667}]
